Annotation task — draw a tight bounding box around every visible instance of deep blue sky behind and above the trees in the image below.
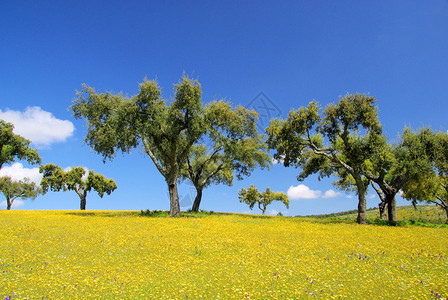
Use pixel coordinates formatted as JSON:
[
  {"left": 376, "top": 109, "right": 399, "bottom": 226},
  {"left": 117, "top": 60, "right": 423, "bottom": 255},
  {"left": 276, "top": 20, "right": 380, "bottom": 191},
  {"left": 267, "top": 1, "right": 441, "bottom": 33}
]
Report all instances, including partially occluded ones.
[{"left": 0, "top": 0, "right": 448, "bottom": 215}]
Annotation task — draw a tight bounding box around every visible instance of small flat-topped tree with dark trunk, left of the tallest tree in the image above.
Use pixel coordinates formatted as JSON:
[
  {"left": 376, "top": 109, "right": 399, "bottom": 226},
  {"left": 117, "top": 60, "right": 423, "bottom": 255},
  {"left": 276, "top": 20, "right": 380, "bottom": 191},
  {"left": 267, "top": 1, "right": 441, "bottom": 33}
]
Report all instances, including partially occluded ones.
[{"left": 39, "top": 164, "right": 117, "bottom": 210}]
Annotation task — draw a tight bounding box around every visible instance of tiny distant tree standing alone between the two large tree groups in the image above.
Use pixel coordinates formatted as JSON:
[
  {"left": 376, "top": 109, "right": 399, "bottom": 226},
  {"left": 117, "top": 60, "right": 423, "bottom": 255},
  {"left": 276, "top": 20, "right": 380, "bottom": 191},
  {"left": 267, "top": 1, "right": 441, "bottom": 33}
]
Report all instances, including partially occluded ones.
[{"left": 238, "top": 185, "right": 289, "bottom": 215}]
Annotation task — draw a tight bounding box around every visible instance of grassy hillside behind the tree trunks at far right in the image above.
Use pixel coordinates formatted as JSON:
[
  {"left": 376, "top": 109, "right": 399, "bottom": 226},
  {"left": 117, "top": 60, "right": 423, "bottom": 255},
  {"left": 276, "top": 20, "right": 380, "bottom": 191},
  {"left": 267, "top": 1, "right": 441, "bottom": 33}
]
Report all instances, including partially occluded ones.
[{"left": 305, "top": 205, "right": 447, "bottom": 224}]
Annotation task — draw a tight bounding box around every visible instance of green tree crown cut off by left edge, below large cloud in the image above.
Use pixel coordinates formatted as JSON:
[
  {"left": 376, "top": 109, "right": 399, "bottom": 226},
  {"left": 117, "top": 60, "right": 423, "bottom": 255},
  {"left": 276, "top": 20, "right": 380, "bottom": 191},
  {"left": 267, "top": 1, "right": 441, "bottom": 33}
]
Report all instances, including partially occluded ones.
[{"left": 0, "top": 120, "right": 40, "bottom": 169}]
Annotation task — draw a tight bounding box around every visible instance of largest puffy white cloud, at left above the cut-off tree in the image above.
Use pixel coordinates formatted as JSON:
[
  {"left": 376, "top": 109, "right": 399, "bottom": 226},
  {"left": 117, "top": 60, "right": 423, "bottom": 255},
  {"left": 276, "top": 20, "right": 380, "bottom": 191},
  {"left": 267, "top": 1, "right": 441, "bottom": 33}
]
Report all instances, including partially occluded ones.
[{"left": 0, "top": 106, "right": 75, "bottom": 146}]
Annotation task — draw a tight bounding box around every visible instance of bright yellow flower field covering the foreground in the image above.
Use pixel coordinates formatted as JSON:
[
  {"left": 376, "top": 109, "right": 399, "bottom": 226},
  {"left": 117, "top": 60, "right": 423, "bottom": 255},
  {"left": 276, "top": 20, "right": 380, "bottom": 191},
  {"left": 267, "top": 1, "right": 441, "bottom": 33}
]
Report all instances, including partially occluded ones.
[{"left": 0, "top": 211, "right": 448, "bottom": 300}]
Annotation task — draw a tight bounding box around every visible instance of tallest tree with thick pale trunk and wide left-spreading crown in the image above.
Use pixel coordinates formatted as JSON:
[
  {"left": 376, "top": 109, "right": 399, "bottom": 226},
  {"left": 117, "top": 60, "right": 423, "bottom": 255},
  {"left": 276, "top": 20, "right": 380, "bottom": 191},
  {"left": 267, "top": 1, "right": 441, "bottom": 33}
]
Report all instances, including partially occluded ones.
[{"left": 71, "top": 76, "right": 206, "bottom": 216}]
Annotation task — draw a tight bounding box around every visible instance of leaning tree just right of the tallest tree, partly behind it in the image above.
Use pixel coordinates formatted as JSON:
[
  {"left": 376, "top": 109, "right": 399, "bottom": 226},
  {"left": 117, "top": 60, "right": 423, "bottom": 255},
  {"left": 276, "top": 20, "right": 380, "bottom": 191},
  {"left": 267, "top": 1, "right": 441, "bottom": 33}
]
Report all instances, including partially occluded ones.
[{"left": 180, "top": 100, "right": 271, "bottom": 212}]
